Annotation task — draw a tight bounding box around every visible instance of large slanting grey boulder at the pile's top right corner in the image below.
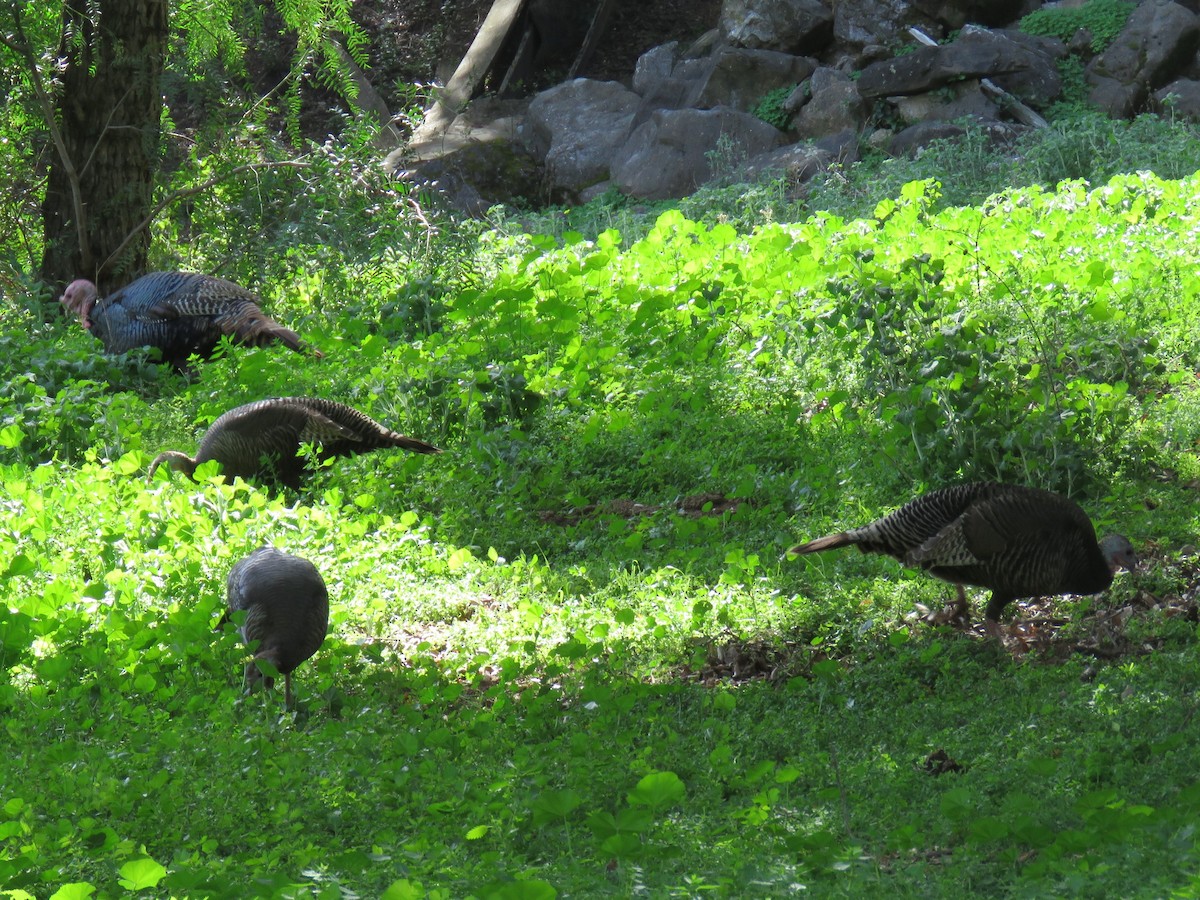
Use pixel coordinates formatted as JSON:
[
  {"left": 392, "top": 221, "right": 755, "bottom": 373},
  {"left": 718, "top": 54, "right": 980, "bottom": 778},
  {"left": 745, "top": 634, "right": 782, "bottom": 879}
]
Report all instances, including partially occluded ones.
[{"left": 1087, "top": 0, "right": 1200, "bottom": 119}]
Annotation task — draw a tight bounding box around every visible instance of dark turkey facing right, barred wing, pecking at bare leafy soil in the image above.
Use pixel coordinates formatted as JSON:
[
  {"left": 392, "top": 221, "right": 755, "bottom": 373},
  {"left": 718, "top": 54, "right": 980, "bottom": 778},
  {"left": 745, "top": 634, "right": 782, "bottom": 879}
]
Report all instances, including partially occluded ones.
[{"left": 788, "top": 482, "right": 1138, "bottom": 624}]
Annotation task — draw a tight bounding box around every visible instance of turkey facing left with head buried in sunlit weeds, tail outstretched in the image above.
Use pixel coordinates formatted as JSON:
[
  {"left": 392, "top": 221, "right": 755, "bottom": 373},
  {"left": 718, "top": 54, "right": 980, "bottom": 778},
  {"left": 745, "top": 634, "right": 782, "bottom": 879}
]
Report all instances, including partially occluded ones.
[{"left": 150, "top": 397, "right": 442, "bottom": 487}]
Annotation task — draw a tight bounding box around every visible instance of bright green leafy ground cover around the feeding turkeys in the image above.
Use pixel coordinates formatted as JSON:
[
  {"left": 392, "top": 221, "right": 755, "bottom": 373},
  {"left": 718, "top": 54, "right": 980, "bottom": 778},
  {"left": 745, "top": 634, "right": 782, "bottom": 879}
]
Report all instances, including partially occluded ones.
[{"left": 0, "top": 121, "right": 1200, "bottom": 898}]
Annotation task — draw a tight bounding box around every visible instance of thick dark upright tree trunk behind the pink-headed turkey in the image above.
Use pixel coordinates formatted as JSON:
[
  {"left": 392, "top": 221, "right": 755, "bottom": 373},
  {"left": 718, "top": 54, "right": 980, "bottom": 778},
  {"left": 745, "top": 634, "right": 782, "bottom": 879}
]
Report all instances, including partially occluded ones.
[{"left": 42, "top": 0, "right": 168, "bottom": 294}]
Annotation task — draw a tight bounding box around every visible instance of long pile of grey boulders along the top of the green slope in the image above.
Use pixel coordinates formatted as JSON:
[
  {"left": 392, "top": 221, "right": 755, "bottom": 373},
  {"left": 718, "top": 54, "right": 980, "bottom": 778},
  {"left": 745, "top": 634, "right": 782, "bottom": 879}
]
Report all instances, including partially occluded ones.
[{"left": 388, "top": 0, "right": 1200, "bottom": 212}]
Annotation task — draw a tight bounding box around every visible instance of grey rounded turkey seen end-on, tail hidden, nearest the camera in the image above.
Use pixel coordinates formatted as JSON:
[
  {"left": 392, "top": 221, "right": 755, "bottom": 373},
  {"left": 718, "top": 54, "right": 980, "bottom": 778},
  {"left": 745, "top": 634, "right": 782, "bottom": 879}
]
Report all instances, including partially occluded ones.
[{"left": 226, "top": 547, "right": 329, "bottom": 709}]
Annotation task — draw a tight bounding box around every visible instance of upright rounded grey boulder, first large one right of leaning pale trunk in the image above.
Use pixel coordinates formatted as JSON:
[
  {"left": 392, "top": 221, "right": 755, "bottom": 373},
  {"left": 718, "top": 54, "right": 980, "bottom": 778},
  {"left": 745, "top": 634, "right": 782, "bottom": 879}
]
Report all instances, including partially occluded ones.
[{"left": 527, "top": 78, "right": 642, "bottom": 192}]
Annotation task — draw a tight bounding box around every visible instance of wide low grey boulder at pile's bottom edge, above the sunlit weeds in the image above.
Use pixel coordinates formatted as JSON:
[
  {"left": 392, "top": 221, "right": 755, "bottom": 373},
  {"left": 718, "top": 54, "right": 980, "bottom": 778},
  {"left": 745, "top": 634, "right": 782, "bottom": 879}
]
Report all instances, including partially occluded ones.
[{"left": 611, "top": 107, "right": 784, "bottom": 200}]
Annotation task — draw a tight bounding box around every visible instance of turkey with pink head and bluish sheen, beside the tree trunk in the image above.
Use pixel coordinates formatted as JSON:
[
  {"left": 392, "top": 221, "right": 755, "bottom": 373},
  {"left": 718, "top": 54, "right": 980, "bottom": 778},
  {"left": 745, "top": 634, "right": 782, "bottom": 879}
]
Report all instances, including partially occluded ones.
[{"left": 60, "top": 272, "right": 323, "bottom": 370}]
